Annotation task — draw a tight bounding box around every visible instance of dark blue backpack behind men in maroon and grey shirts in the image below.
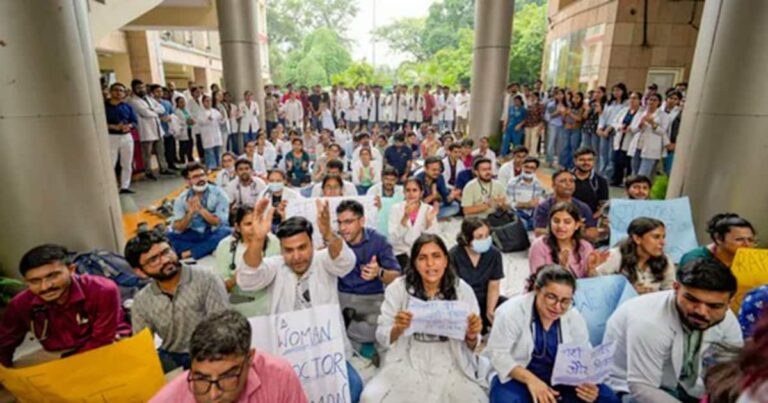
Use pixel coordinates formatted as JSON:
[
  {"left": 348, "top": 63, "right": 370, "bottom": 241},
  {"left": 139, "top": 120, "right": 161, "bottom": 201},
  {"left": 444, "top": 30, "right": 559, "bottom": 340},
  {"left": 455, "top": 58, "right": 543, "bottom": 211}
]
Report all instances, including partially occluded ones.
[{"left": 73, "top": 249, "right": 150, "bottom": 315}]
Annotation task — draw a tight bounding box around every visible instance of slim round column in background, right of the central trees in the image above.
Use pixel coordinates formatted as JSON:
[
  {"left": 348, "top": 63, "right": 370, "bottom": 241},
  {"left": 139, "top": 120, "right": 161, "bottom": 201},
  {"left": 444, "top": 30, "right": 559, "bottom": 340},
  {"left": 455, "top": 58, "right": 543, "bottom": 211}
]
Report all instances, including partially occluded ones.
[{"left": 469, "top": 0, "right": 515, "bottom": 140}]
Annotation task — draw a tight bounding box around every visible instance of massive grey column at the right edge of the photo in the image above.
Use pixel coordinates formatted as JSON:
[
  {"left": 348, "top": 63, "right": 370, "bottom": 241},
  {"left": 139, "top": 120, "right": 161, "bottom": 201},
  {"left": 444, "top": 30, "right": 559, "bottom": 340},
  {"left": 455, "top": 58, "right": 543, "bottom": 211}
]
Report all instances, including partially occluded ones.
[{"left": 667, "top": 0, "right": 768, "bottom": 242}]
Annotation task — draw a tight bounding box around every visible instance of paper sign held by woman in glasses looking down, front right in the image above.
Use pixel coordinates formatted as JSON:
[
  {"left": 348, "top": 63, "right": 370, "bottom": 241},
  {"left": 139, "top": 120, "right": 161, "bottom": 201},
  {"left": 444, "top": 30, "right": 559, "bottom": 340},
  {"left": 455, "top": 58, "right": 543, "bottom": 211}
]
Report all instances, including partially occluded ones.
[{"left": 552, "top": 342, "right": 616, "bottom": 386}]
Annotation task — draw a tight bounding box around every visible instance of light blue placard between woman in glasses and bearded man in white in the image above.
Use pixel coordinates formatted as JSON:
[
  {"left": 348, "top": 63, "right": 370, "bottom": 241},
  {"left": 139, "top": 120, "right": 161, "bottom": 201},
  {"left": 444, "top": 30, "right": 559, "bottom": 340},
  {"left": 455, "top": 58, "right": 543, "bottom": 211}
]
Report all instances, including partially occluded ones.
[{"left": 573, "top": 274, "right": 637, "bottom": 345}]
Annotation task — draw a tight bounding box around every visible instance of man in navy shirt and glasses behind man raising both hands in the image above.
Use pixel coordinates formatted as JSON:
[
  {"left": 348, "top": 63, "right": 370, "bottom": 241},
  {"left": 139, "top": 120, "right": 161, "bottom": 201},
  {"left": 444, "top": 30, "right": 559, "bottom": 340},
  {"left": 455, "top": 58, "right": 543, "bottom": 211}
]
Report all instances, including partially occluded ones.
[{"left": 336, "top": 200, "right": 401, "bottom": 351}]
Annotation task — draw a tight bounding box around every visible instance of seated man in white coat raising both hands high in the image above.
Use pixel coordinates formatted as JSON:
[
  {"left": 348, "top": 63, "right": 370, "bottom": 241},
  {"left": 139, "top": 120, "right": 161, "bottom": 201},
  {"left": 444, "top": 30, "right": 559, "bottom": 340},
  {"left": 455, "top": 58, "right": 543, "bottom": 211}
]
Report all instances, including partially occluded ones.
[{"left": 237, "top": 199, "right": 363, "bottom": 402}]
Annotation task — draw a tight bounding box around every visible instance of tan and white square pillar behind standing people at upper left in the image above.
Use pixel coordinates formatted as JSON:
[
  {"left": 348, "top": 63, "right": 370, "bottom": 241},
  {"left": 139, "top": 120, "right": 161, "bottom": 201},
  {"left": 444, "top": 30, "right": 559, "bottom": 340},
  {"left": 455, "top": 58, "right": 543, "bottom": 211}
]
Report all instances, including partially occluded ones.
[{"left": 124, "top": 31, "right": 165, "bottom": 88}]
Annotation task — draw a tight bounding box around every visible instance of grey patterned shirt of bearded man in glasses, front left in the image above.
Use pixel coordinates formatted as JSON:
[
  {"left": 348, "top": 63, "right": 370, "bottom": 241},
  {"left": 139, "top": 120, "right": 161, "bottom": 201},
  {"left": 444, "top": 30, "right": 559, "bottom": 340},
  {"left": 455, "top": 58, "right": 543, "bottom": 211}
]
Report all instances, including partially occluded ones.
[{"left": 131, "top": 266, "right": 229, "bottom": 353}]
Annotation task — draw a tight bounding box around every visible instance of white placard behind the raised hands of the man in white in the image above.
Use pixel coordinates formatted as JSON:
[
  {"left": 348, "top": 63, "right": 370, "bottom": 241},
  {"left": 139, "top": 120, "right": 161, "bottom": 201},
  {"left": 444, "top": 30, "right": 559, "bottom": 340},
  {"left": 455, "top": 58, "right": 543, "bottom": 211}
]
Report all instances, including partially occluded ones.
[{"left": 285, "top": 196, "right": 379, "bottom": 247}]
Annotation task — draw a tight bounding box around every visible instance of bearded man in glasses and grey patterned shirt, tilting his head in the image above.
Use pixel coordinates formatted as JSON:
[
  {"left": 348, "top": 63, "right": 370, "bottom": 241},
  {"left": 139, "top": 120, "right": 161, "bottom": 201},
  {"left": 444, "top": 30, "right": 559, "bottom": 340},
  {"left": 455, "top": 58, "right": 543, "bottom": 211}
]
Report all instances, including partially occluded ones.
[{"left": 125, "top": 231, "right": 229, "bottom": 372}]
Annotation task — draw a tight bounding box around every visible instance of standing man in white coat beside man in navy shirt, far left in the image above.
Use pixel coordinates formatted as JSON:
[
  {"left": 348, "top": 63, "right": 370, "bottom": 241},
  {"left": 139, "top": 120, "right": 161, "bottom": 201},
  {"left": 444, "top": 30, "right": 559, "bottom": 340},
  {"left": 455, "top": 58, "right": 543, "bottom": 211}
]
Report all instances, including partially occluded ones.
[{"left": 128, "top": 80, "right": 169, "bottom": 180}]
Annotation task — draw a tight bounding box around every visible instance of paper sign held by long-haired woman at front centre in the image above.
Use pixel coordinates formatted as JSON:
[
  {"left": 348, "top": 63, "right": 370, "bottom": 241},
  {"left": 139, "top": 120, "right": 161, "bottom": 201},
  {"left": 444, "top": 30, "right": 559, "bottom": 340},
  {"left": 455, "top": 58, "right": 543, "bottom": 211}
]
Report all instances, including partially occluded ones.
[{"left": 405, "top": 298, "right": 470, "bottom": 340}]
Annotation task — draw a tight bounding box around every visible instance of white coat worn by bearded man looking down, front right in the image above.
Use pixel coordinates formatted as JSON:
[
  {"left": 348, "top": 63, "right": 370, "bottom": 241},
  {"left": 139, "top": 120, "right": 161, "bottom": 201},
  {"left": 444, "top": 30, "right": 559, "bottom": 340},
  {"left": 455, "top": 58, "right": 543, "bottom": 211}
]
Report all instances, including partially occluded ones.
[{"left": 608, "top": 290, "right": 743, "bottom": 403}]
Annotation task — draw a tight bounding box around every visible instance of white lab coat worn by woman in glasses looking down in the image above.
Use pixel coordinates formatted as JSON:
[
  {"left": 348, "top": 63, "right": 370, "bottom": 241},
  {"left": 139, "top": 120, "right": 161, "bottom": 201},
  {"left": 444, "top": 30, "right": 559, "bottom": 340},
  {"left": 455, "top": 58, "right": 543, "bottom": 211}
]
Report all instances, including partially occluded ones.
[{"left": 483, "top": 292, "right": 589, "bottom": 383}]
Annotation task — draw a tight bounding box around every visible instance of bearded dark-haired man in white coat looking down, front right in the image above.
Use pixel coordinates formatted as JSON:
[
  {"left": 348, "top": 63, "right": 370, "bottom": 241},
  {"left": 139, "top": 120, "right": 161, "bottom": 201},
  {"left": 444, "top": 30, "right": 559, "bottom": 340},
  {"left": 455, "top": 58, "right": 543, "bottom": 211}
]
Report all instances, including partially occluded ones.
[{"left": 604, "top": 260, "right": 743, "bottom": 403}]
